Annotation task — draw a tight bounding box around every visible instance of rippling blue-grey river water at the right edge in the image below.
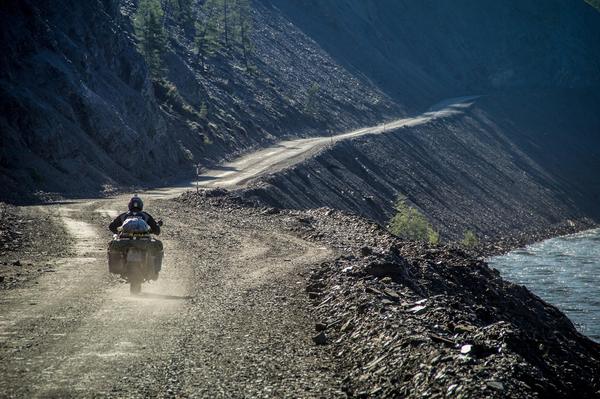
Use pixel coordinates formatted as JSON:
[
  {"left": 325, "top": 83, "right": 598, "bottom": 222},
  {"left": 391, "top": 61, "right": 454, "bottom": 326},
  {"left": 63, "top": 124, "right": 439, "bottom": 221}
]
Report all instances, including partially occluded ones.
[{"left": 488, "top": 229, "right": 600, "bottom": 342}]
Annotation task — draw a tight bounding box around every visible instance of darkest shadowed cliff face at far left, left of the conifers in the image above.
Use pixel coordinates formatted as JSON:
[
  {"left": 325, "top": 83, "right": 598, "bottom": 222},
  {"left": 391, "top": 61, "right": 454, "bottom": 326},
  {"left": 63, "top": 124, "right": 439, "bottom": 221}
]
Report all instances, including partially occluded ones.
[{"left": 0, "top": 1, "right": 185, "bottom": 199}]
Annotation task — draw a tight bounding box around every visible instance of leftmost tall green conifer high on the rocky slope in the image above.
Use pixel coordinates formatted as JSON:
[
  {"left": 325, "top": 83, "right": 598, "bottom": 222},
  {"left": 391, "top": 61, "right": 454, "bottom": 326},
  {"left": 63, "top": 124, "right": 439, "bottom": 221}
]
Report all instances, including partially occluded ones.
[{"left": 133, "top": 0, "right": 167, "bottom": 80}]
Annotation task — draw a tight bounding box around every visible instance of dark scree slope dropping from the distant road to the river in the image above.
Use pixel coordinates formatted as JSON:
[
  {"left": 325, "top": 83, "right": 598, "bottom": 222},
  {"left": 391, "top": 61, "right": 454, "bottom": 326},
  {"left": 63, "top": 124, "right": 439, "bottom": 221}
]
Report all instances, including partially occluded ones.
[{"left": 245, "top": 90, "right": 600, "bottom": 239}]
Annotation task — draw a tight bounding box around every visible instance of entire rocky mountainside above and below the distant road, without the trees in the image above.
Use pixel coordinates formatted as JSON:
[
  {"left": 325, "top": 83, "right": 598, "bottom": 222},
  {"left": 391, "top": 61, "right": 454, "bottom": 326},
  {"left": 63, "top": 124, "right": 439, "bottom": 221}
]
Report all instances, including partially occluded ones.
[{"left": 0, "top": 0, "right": 600, "bottom": 244}]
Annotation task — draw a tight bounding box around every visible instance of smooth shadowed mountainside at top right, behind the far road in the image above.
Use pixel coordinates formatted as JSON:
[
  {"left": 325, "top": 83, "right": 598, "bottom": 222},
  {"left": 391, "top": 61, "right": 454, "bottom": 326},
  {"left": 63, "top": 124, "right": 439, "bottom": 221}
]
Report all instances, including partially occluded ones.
[{"left": 263, "top": 0, "right": 600, "bottom": 109}]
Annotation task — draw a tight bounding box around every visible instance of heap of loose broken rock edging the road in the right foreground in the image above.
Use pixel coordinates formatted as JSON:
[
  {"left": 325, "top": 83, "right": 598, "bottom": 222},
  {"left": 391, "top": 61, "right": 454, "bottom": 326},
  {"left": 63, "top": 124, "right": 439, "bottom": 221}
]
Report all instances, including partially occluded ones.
[{"left": 179, "top": 190, "right": 600, "bottom": 398}]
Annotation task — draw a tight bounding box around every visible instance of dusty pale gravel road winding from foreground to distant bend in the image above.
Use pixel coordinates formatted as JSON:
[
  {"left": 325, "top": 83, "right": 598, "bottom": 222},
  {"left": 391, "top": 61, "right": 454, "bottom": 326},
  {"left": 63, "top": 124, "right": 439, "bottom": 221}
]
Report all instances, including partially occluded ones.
[{"left": 0, "top": 99, "right": 470, "bottom": 398}]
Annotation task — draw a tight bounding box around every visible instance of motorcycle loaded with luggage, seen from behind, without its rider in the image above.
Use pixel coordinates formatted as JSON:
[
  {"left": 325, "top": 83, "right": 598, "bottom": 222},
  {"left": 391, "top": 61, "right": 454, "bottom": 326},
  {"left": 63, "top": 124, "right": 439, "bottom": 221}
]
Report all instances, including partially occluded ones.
[{"left": 108, "top": 217, "right": 163, "bottom": 295}]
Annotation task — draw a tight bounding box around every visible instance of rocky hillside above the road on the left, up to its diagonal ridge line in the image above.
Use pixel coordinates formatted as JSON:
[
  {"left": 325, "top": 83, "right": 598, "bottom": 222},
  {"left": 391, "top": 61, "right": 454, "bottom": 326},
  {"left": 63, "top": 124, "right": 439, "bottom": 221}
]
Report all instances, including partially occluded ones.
[{"left": 0, "top": 0, "right": 403, "bottom": 201}]
